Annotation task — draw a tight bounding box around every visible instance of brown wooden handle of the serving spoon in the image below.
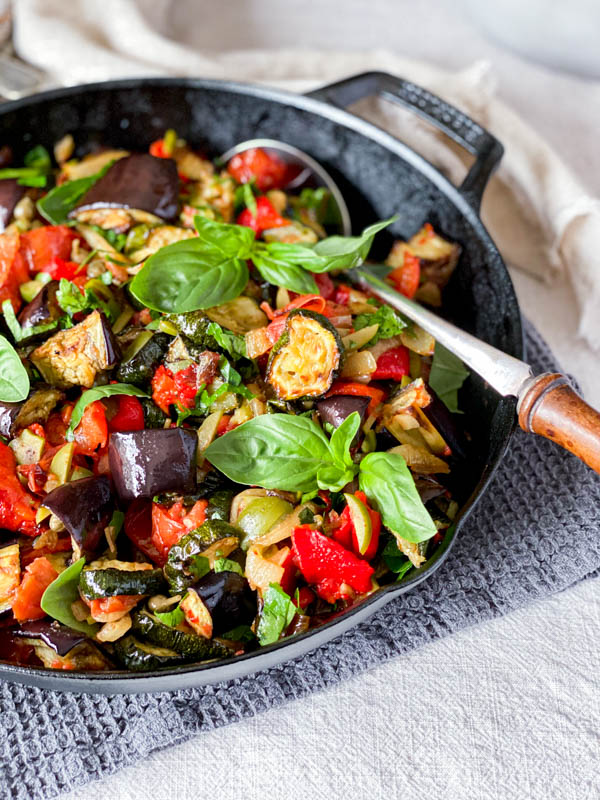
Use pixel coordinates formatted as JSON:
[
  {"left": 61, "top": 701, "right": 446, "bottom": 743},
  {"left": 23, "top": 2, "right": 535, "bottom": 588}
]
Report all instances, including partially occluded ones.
[{"left": 517, "top": 372, "right": 600, "bottom": 472}]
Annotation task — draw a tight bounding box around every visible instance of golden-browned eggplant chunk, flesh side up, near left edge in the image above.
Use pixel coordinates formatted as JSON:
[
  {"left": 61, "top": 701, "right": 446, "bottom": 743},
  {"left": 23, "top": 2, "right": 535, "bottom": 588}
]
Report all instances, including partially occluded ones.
[{"left": 30, "top": 311, "right": 119, "bottom": 389}]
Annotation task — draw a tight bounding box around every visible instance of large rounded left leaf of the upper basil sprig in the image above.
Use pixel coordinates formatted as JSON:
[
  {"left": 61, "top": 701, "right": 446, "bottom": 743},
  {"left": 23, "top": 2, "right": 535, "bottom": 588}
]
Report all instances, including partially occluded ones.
[{"left": 130, "top": 238, "right": 254, "bottom": 314}]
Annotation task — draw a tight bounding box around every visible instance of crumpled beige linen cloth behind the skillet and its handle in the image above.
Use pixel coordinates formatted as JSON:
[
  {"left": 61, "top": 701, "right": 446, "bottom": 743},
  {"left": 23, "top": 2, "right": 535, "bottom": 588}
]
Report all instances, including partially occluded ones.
[{"left": 13, "top": 0, "right": 600, "bottom": 348}]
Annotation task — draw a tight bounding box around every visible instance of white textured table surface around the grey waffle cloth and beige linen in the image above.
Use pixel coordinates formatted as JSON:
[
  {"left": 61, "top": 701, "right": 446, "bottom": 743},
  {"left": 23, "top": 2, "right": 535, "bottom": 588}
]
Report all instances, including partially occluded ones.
[{"left": 55, "top": 0, "right": 600, "bottom": 800}]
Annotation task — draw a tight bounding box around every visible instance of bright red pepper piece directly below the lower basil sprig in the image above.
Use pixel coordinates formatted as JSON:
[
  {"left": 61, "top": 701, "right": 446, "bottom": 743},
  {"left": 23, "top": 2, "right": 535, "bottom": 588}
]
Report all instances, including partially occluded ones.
[{"left": 292, "top": 526, "right": 374, "bottom": 603}]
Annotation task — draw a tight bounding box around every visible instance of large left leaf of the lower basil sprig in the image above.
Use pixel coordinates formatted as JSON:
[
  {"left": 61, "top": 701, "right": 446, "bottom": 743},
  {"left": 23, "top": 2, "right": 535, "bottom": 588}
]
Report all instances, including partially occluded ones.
[{"left": 204, "top": 414, "right": 331, "bottom": 493}]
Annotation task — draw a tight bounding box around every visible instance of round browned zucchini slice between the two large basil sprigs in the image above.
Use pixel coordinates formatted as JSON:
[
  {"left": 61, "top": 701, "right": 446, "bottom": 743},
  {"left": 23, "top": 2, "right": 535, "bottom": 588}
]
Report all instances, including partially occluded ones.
[{"left": 266, "top": 309, "right": 344, "bottom": 400}]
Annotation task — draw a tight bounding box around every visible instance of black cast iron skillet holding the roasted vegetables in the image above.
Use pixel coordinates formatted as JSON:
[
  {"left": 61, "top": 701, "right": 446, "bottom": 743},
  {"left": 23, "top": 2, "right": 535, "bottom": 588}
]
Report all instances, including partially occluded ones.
[{"left": 0, "top": 73, "right": 524, "bottom": 693}]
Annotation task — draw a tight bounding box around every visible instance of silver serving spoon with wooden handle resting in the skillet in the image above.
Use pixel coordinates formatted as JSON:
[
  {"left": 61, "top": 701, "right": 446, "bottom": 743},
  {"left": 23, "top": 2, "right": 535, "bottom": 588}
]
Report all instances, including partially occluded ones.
[{"left": 221, "top": 139, "right": 600, "bottom": 473}]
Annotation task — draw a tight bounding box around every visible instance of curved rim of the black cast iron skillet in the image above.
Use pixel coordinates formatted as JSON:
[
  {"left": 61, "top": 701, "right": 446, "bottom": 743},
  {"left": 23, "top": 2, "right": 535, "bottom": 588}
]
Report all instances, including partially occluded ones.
[{"left": 0, "top": 77, "right": 525, "bottom": 694}]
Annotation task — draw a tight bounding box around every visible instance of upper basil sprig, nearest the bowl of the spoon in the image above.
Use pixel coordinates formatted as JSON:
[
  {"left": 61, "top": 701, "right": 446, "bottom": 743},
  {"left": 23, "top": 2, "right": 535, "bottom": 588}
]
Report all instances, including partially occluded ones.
[{"left": 130, "top": 216, "right": 396, "bottom": 314}]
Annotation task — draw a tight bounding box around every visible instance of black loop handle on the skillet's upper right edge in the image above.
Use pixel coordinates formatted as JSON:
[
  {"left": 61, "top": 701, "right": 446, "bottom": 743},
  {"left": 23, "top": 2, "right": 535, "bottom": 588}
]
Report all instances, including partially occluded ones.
[{"left": 307, "top": 72, "right": 504, "bottom": 210}]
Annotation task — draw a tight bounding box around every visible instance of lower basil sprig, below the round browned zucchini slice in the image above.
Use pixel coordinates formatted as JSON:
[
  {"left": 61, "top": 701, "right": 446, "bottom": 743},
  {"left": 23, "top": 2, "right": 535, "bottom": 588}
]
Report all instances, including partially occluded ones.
[{"left": 204, "top": 412, "right": 437, "bottom": 542}]
